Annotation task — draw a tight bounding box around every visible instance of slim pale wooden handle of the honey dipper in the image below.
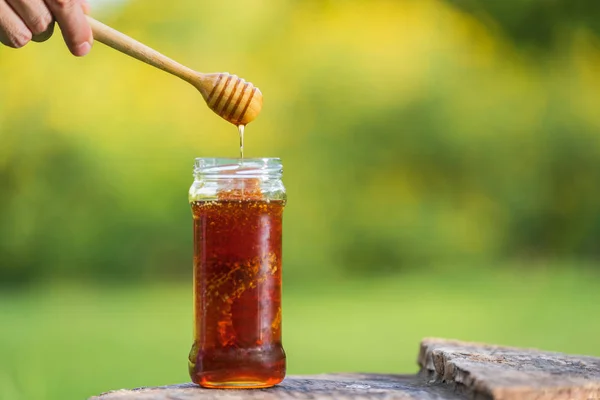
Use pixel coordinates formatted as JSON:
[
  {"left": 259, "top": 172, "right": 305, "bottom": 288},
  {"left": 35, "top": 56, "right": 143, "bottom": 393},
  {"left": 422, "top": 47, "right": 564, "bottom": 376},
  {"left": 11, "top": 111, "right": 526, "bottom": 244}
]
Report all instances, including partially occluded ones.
[{"left": 86, "top": 16, "right": 198, "bottom": 84}]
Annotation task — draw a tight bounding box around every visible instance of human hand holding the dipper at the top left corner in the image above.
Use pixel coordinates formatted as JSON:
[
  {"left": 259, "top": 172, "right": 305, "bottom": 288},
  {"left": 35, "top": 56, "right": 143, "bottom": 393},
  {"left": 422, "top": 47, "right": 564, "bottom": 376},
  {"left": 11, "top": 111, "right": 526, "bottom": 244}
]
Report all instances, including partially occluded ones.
[{"left": 0, "top": 0, "right": 93, "bottom": 56}]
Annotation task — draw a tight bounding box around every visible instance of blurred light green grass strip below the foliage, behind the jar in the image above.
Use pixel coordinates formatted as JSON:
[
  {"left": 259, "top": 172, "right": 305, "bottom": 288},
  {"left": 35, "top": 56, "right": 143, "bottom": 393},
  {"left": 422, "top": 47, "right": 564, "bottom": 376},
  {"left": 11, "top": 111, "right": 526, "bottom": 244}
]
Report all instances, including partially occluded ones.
[{"left": 0, "top": 264, "right": 600, "bottom": 400}]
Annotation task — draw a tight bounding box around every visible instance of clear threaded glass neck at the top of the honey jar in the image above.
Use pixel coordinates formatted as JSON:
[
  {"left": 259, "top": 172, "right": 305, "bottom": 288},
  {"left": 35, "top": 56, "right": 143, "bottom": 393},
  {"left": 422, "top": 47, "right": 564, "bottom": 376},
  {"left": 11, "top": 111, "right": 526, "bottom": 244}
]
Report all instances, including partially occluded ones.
[{"left": 194, "top": 158, "right": 283, "bottom": 180}]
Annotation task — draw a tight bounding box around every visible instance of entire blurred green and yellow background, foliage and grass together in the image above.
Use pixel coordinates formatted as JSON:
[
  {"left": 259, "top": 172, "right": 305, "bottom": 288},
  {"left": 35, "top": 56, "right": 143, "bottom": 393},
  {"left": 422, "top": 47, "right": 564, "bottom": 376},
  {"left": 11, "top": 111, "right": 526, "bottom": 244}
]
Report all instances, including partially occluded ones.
[{"left": 0, "top": 0, "right": 600, "bottom": 400}]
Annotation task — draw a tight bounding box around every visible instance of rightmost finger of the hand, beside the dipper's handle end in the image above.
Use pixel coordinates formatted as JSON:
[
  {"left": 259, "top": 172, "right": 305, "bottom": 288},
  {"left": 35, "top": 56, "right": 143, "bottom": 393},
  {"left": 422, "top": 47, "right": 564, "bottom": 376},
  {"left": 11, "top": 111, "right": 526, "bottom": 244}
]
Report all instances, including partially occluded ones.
[{"left": 45, "top": 0, "right": 93, "bottom": 56}]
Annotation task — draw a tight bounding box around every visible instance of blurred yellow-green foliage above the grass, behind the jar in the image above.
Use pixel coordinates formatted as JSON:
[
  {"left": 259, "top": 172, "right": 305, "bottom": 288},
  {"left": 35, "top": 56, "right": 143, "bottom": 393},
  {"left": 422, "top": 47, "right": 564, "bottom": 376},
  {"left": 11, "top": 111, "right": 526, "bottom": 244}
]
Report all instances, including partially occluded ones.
[{"left": 0, "top": 0, "right": 600, "bottom": 285}]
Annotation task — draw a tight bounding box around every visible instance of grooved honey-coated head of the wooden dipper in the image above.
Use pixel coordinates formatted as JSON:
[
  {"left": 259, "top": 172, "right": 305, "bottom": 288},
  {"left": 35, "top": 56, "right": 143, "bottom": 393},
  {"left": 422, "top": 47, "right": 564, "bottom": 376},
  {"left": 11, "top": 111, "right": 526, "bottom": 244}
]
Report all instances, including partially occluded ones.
[{"left": 198, "top": 73, "right": 262, "bottom": 125}]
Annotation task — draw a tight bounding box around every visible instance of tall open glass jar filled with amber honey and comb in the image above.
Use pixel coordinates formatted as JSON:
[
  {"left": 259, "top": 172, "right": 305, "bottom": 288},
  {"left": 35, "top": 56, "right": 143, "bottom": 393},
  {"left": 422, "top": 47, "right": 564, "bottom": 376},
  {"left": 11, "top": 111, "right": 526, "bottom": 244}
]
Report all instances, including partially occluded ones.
[{"left": 189, "top": 158, "right": 286, "bottom": 388}]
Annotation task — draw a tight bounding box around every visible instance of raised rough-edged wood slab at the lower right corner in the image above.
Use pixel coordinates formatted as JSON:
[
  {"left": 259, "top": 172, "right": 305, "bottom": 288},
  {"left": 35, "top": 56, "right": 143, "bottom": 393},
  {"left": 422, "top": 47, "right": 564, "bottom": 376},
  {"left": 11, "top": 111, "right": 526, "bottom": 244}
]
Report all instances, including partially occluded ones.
[{"left": 418, "top": 337, "right": 600, "bottom": 400}]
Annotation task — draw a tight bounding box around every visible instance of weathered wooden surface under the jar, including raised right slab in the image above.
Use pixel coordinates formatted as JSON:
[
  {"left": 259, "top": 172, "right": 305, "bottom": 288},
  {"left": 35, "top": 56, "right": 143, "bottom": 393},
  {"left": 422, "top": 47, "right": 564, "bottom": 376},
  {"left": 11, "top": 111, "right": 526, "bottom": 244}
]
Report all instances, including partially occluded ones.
[{"left": 91, "top": 339, "right": 600, "bottom": 400}]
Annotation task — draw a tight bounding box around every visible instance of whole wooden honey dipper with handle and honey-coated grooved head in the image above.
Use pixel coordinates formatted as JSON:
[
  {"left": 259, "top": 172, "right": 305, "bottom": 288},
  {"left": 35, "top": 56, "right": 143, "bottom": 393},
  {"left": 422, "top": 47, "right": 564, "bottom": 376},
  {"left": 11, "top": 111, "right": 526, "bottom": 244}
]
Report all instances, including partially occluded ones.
[{"left": 87, "top": 16, "right": 262, "bottom": 126}]
